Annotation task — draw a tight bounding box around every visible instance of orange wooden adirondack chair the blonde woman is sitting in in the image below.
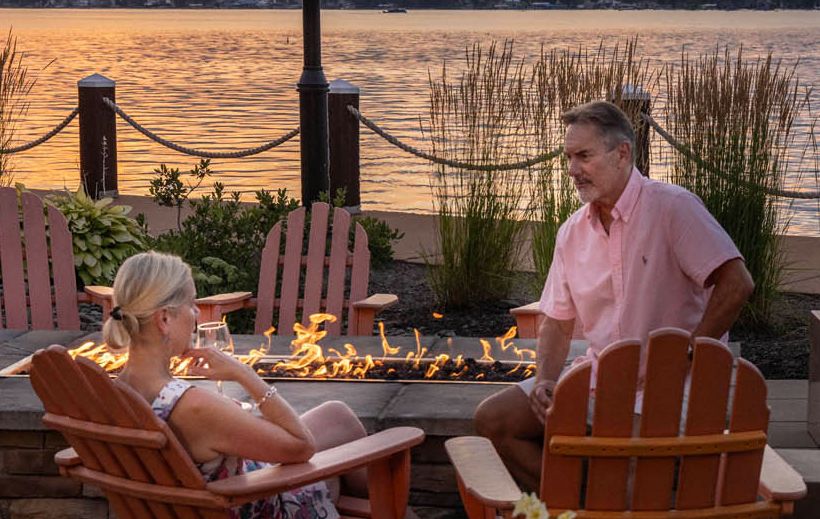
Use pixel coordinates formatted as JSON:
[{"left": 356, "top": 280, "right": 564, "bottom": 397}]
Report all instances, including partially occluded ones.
[{"left": 31, "top": 345, "right": 424, "bottom": 519}]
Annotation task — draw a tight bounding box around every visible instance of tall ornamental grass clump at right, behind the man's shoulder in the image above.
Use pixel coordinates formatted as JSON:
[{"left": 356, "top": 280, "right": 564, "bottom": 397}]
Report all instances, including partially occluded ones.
[{"left": 665, "top": 48, "right": 813, "bottom": 327}]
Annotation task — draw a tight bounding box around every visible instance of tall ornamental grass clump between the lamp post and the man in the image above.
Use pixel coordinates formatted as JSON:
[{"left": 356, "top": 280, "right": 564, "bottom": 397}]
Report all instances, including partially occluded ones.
[{"left": 425, "top": 42, "right": 532, "bottom": 307}]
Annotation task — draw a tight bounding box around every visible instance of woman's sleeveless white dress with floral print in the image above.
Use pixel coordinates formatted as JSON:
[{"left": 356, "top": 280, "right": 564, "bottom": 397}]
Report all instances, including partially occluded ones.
[{"left": 151, "top": 379, "right": 339, "bottom": 519}]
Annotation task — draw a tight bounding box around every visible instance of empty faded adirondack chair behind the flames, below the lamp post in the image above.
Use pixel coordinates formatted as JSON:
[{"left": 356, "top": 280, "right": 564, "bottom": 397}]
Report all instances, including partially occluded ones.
[{"left": 197, "top": 202, "right": 398, "bottom": 335}]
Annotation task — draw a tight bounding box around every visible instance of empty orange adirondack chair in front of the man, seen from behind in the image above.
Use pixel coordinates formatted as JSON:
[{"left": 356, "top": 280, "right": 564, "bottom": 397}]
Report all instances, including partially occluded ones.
[{"left": 446, "top": 328, "right": 806, "bottom": 519}]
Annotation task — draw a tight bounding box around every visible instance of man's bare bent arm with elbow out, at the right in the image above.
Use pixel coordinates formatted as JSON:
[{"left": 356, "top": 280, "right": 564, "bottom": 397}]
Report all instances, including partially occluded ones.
[{"left": 692, "top": 259, "right": 754, "bottom": 339}]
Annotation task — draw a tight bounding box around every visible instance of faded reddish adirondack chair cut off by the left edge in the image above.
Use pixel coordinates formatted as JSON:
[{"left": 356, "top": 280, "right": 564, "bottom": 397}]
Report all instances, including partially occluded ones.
[{"left": 0, "top": 187, "right": 111, "bottom": 330}]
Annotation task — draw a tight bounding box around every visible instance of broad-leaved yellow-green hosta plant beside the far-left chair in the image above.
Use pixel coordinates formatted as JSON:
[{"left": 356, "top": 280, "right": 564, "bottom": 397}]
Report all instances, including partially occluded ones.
[{"left": 45, "top": 186, "right": 146, "bottom": 285}]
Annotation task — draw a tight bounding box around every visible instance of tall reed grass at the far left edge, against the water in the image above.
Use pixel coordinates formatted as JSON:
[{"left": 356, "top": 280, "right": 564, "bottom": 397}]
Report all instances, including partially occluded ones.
[{"left": 0, "top": 29, "right": 34, "bottom": 186}]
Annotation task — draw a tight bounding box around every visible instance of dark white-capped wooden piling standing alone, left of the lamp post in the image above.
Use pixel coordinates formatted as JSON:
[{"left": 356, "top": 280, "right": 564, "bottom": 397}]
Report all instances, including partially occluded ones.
[{"left": 77, "top": 74, "right": 119, "bottom": 198}]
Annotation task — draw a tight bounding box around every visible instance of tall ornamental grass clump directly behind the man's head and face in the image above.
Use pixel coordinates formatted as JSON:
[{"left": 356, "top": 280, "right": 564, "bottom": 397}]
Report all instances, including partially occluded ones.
[{"left": 525, "top": 38, "right": 658, "bottom": 289}]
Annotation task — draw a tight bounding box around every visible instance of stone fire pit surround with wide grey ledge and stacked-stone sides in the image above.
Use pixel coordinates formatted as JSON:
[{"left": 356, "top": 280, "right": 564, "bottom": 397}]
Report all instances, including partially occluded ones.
[{"left": 0, "top": 330, "right": 600, "bottom": 519}]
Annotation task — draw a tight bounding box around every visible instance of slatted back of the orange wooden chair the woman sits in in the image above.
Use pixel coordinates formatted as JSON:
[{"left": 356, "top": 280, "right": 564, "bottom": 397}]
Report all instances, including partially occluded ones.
[{"left": 31, "top": 345, "right": 227, "bottom": 519}]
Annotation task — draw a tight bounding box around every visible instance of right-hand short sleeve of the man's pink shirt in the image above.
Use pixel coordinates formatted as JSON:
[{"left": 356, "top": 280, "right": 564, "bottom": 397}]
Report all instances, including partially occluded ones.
[{"left": 668, "top": 191, "right": 743, "bottom": 287}]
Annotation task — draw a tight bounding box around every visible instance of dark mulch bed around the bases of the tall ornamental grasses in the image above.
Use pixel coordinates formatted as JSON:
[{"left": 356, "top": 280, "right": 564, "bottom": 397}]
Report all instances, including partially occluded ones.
[{"left": 370, "top": 261, "right": 820, "bottom": 379}]
